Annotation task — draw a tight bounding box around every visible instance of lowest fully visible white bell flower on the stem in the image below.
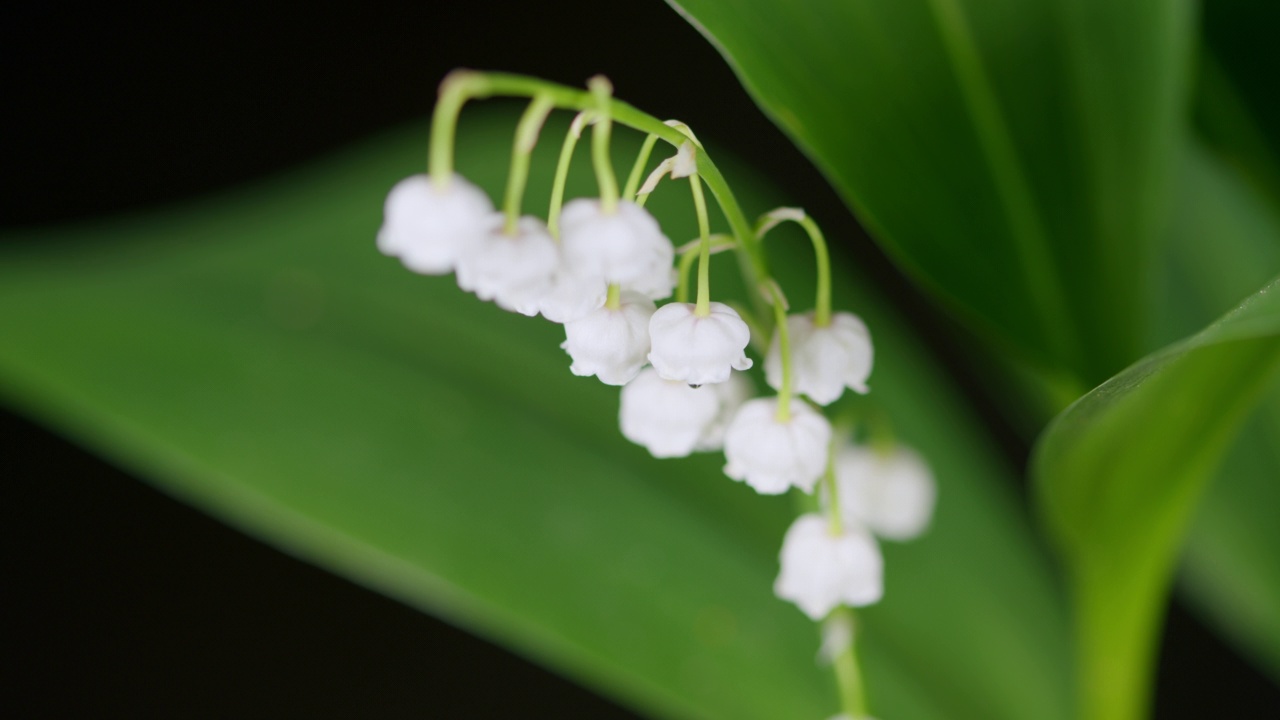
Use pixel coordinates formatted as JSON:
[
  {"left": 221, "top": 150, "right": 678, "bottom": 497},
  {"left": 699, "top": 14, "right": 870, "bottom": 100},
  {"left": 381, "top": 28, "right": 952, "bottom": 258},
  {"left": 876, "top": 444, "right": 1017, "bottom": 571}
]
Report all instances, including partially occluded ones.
[{"left": 773, "top": 514, "right": 884, "bottom": 621}]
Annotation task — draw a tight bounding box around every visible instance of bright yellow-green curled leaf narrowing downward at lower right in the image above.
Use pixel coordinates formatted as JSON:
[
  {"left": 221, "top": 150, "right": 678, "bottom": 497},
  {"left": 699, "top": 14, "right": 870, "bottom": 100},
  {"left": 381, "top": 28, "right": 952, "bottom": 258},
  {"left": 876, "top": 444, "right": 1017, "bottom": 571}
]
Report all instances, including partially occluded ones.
[{"left": 1033, "top": 274, "right": 1280, "bottom": 720}]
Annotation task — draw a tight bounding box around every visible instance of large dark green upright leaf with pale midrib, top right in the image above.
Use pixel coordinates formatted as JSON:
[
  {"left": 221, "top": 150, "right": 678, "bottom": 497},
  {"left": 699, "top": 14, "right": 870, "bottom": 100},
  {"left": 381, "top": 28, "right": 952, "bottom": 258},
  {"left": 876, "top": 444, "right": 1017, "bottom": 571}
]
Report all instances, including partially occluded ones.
[{"left": 672, "top": 0, "right": 1193, "bottom": 384}]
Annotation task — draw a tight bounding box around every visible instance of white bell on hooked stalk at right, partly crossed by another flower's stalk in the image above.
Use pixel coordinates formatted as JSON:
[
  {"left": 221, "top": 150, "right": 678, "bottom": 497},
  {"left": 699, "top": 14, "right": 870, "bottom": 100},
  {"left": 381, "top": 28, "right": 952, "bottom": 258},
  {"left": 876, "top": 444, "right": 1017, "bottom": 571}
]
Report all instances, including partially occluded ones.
[{"left": 764, "top": 313, "right": 873, "bottom": 405}]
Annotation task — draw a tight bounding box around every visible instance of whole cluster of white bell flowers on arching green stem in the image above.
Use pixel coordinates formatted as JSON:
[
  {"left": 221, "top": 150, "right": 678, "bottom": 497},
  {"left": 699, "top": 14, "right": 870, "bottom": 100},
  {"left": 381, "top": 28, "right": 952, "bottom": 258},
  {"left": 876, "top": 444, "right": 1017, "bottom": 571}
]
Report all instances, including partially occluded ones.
[{"left": 378, "top": 73, "right": 934, "bottom": 717}]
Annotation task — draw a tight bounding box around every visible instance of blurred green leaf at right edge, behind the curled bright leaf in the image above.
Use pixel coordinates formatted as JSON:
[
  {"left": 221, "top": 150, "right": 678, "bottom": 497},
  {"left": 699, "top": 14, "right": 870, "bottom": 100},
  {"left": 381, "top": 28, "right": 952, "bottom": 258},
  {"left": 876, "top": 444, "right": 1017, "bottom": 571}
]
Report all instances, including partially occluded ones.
[{"left": 1157, "top": 145, "right": 1280, "bottom": 679}]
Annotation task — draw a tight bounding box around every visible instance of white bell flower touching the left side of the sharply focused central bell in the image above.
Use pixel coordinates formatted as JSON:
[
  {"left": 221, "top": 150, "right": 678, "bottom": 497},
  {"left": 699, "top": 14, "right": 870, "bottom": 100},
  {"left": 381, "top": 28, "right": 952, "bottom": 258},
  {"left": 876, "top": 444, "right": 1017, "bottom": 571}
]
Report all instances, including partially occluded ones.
[{"left": 561, "top": 292, "right": 654, "bottom": 386}]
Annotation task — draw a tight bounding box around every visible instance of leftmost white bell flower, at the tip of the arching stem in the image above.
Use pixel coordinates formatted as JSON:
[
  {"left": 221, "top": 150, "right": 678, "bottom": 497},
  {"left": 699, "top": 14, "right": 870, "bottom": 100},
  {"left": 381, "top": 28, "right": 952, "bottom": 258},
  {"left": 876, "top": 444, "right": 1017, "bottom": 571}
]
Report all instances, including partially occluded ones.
[{"left": 378, "top": 174, "right": 493, "bottom": 275}]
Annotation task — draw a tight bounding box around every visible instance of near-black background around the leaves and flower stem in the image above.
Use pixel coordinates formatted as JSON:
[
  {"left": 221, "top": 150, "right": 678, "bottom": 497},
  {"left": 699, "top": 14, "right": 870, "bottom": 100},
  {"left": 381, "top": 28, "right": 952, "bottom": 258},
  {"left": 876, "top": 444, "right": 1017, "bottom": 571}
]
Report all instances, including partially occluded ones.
[{"left": 0, "top": 0, "right": 1280, "bottom": 720}]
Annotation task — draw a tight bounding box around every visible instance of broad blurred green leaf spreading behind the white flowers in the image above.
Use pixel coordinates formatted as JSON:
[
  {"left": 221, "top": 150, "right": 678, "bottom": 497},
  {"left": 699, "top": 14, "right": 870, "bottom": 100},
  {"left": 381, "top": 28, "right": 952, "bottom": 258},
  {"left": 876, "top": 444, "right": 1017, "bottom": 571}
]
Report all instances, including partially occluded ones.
[{"left": 0, "top": 111, "right": 1068, "bottom": 720}]
